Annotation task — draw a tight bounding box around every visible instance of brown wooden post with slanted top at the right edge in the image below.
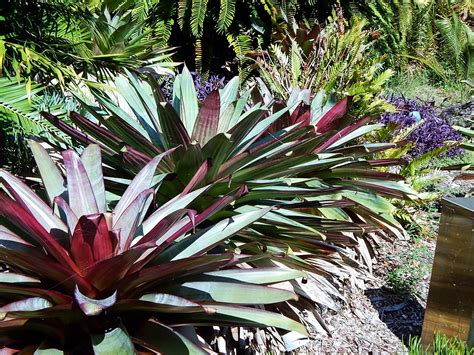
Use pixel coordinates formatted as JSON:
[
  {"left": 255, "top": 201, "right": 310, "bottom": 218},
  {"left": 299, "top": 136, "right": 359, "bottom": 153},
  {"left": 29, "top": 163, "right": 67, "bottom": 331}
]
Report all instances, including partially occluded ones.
[{"left": 421, "top": 198, "right": 474, "bottom": 346}]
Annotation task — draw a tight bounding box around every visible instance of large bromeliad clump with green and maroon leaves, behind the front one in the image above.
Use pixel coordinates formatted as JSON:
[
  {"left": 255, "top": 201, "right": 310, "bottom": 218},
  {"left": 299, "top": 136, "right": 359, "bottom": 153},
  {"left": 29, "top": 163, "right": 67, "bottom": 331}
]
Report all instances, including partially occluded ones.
[{"left": 40, "top": 69, "right": 412, "bottom": 318}]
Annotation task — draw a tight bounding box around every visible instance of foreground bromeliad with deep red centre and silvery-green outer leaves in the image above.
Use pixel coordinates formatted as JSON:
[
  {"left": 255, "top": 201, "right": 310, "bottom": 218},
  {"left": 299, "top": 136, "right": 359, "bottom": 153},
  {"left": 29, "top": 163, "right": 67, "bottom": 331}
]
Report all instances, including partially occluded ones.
[{"left": 0, "top": 142, "right": 305, "bottom": 354}]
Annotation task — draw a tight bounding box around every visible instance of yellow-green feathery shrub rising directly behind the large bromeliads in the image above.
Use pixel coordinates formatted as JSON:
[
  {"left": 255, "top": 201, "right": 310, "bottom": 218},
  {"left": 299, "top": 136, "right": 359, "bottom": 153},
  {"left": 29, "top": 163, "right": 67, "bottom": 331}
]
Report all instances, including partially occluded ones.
[{"left": 256, "top": 18, "right": 392, "bottom": 116}]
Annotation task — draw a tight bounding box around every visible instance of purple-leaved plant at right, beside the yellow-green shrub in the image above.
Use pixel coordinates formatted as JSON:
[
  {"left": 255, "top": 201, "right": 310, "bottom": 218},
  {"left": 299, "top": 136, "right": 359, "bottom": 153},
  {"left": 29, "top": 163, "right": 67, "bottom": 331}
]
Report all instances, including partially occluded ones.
[{"left": 381, "top": 97, "right": 462, "bottom": 157}]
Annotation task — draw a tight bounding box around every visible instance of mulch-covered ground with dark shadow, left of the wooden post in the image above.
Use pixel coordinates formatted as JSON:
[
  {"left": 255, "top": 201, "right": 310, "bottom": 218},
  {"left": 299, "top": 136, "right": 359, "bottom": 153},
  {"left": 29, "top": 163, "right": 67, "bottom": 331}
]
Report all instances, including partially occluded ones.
[{"left": 299, "top": 235, "right": 436, "bottom": 354}]
